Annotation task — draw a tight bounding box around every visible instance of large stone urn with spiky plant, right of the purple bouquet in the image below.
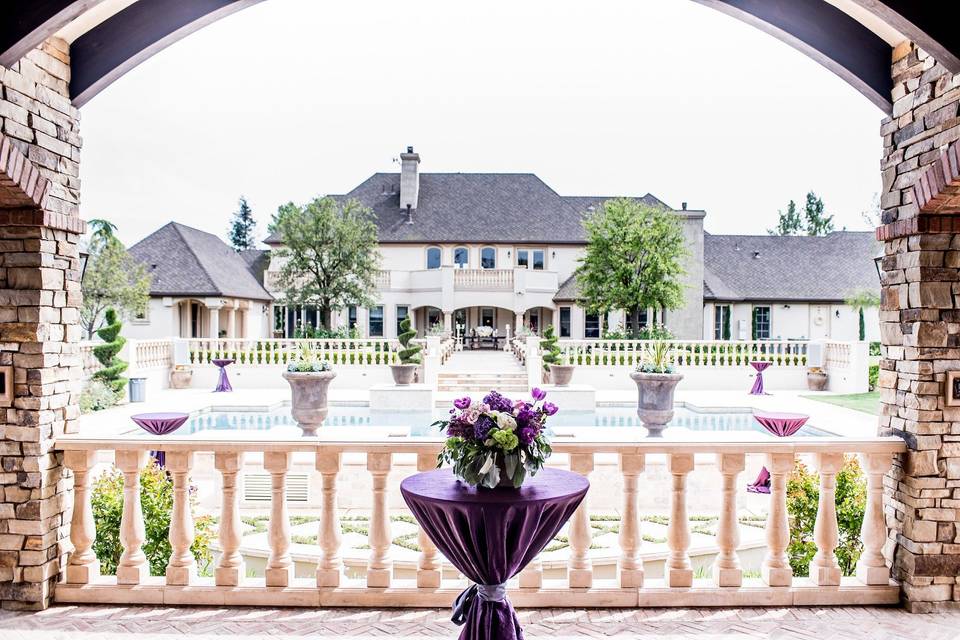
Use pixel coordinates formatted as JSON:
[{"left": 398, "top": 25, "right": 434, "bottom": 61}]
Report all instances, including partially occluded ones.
[{"left": 630, "top": 340, "right": 683, "bottom": 438}]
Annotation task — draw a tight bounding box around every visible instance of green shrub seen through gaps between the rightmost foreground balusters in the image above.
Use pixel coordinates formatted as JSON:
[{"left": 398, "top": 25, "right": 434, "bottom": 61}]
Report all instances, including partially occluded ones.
[{"left": 787, "top": 456, "right": 867, "bottom": 576}]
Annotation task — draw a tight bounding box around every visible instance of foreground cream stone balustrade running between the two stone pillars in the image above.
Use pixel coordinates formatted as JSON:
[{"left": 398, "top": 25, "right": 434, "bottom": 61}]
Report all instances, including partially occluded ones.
[{"left": 55, "top": 430, "right": 905, "bottom": 607}]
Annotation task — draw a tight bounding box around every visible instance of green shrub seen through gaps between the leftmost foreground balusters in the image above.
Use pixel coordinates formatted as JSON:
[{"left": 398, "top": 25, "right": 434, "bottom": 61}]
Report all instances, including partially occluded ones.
[{"left": 91, "top": 463, "right": 214, "bottom": 576}]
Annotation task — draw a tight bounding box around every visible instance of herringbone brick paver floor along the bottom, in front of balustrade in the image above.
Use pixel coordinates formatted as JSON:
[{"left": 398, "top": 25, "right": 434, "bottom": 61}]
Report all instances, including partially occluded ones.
[{"left": 0, "top": 606, "right": 960, "bottom": 640}]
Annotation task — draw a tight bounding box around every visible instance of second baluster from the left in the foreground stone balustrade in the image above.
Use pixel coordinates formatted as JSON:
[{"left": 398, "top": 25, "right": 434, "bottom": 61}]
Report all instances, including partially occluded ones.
[{"left": 114, "top": 449, "right": 150, "bottom": 584}]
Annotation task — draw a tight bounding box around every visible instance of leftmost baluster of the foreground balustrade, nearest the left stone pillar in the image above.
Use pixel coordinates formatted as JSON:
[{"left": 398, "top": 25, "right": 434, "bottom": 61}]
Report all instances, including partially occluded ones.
[{"left": 63, "top": 451, "right": 100, "bottom": 584}]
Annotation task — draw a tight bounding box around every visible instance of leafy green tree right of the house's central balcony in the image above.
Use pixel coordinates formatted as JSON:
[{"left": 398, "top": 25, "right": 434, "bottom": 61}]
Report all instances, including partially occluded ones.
[{"left": 576, "top": 198, "right": 689, "bottom": 335}]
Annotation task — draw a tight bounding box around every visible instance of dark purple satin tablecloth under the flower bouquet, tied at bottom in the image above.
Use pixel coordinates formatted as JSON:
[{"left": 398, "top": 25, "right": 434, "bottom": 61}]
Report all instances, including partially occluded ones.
[{"left": 400, "top": 469, "right": 590, "bottom": 640}]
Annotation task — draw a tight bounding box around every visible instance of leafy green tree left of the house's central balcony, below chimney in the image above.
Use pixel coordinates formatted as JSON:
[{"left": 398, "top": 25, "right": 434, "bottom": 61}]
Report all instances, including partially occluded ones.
[{"left": 270, "top": 197, "right": 380, "bottom": 328}]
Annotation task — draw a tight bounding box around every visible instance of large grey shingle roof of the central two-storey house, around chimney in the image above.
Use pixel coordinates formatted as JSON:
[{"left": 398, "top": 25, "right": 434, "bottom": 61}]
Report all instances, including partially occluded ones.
[{"left": 265, "top": 173, "right": 684, "bottom": 244}]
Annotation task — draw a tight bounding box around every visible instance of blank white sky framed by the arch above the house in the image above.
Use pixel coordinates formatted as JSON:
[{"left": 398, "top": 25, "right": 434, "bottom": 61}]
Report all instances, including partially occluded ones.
[{"left": 81, "top": 0, "right": 883, "bottom": 244}]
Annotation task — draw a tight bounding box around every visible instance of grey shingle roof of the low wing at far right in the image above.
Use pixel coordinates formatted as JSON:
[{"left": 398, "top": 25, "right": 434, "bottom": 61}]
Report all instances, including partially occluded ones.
[{"left": 703, "top": 231, "right": 882, "bottom": 302}]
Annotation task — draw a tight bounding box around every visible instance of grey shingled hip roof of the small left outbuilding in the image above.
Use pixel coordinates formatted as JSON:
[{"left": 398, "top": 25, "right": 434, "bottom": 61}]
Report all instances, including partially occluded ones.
[{"left": 130, "top": 222, "right": 272, "bottom": 300}]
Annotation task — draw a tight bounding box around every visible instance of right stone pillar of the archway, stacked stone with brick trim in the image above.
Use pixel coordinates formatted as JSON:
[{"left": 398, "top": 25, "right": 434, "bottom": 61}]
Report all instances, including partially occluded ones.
[{"left": 878, "top": 43, "right": 960, "bottom": 612}]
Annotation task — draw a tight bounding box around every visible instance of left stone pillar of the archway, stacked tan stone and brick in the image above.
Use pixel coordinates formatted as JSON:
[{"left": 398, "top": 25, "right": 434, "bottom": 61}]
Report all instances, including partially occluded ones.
[{"left": 0, "top": 39, "right": 83, "bottom": 609}]
